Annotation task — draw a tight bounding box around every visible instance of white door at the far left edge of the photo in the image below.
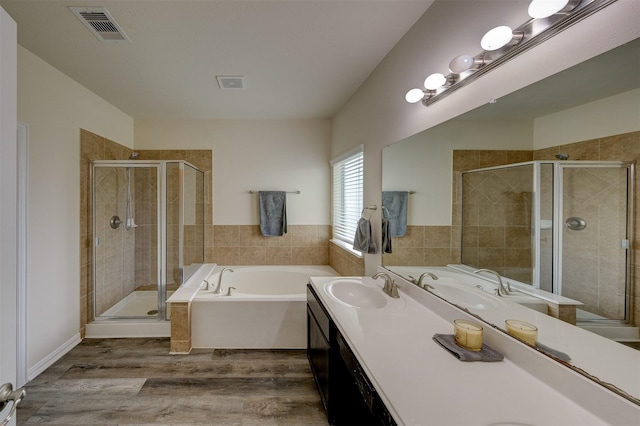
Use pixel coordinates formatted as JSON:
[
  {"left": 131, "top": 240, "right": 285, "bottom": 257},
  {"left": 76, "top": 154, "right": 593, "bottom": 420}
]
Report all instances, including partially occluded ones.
[{"left": 0, "top": 8, "right": 18, "bottom": 424}]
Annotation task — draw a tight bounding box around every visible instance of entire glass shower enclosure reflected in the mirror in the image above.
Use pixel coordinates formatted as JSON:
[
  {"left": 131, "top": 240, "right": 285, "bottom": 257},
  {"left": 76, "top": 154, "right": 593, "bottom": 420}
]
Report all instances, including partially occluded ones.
[{"left": 461, "top": 161, "right": 634, "bottom": 324}]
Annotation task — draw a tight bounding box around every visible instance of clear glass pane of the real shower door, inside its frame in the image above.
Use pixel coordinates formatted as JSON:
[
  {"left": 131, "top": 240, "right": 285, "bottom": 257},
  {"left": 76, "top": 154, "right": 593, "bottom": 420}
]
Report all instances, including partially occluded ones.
[{"left": 92, "top": 163, "right": 162, "bottom": 319}]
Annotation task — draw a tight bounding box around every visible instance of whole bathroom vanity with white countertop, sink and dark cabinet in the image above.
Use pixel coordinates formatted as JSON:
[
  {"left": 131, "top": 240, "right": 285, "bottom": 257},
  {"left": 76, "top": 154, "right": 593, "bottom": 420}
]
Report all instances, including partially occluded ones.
[{"left": 307, "top": 276, "right": 640, "bottom": 426}]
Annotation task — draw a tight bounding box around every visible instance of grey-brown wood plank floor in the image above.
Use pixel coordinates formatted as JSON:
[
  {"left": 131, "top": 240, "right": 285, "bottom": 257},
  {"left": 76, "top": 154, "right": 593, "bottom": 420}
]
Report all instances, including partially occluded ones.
[{"left": 17, "top": 338, "right": 327, "bottom": 426}]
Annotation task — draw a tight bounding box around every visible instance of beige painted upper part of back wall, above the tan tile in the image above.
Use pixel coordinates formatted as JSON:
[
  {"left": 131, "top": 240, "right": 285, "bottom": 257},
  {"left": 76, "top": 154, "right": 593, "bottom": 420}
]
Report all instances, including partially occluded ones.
[{"left": 136, "top": 120, "right": 331, "bottom": 225}]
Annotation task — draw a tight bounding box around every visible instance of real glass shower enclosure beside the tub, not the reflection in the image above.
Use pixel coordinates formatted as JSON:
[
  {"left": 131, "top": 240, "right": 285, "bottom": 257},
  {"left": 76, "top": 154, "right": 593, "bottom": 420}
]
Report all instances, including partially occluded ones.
[{"left": 91, "top": 160, "right": 204, "bottom": 320}]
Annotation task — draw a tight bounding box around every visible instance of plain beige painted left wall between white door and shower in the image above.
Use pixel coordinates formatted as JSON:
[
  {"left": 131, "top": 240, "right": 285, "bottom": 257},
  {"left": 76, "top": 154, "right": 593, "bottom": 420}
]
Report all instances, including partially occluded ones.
[{"left": 18, "top": 46, "right": 133, "bottom": 370}]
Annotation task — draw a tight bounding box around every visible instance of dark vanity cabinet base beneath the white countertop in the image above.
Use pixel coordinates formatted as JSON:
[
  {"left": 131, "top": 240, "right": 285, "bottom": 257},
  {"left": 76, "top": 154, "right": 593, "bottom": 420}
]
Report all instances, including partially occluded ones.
[{"left": 307, "top": 285, "right": 396, "bottom": 425}]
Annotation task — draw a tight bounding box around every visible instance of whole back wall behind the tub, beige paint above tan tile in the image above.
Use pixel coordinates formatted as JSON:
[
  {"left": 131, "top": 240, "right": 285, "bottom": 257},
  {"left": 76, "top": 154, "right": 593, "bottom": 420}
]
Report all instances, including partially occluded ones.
[{"left": 136, "top": 120, "right": 331, "bottom": 265}]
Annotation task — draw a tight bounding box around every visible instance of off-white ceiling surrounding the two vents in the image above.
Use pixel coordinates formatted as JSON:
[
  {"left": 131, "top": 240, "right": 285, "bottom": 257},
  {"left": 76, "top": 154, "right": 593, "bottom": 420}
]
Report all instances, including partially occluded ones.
[{"left": 0, "top": 0, "right": 433, "bottom": 120}]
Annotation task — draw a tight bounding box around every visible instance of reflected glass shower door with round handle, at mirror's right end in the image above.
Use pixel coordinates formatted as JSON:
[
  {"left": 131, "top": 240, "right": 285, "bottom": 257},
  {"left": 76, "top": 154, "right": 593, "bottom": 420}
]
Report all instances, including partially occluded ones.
[{"left": 557, "top": 164, "right": 632, "bottom": 322}]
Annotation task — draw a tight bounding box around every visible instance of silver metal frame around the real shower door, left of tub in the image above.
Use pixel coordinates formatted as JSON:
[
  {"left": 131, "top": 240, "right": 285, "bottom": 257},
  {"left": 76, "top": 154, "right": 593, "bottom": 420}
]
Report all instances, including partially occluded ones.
[{"left": 90, "top": 160, "right": 166, "bottom": 320}]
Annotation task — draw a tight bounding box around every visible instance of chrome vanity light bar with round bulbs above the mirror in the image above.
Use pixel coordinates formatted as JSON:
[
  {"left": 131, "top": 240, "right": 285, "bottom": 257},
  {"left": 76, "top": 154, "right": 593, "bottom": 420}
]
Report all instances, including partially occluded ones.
[{"left": 405, "top": 0, "right": 616, "bottom": 106}]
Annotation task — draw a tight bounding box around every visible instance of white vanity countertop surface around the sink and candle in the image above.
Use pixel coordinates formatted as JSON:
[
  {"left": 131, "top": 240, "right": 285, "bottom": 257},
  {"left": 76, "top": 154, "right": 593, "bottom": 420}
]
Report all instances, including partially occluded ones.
[{"left": 311, "top": 277, "right": 640, "bottom": 426}]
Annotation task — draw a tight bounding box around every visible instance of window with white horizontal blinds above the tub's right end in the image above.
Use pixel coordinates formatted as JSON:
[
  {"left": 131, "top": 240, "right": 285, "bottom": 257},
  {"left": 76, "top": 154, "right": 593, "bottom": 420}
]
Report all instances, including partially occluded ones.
[{"left": 331, "top": 145, "right": 364, "bottom": 244}]
